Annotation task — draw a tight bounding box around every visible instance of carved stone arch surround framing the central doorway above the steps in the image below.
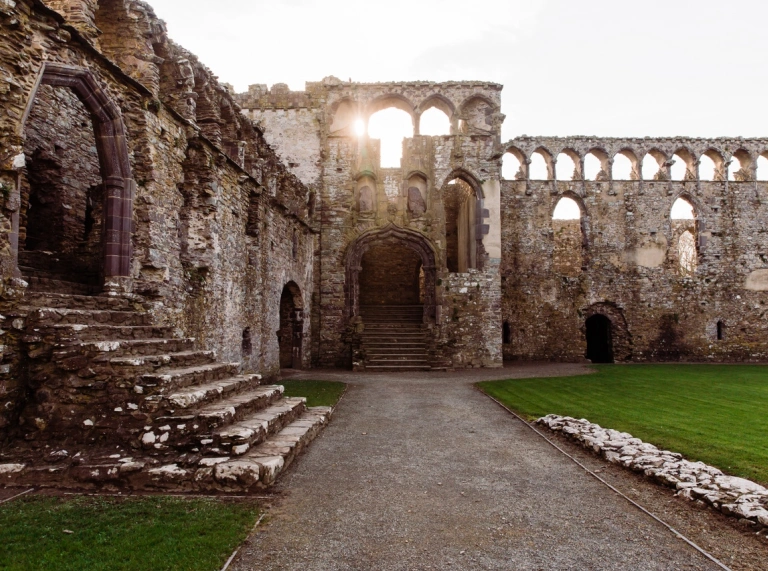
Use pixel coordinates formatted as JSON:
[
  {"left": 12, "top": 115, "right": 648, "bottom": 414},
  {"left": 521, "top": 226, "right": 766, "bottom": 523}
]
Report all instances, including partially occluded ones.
[{"left": 344, "top": 224, "right": 438, "bottom": 321}]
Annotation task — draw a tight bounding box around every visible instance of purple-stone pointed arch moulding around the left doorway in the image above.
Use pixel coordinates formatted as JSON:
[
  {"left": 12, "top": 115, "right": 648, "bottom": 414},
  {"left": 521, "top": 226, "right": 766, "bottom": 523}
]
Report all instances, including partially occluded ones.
[{"left": 19, "top": 62, "right": 136, "bottom": 291}]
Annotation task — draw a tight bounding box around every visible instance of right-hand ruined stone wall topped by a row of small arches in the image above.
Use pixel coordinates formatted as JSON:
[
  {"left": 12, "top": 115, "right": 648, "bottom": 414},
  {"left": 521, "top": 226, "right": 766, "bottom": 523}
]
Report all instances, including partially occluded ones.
[{"left": 502, "top": 137, "right": 768, "bottom": 361}]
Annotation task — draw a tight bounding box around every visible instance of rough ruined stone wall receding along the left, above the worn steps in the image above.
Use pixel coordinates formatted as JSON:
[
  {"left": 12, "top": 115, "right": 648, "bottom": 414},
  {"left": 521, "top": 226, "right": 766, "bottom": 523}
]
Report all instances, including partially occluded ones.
[{"left": 0, "top": 0, "right": 315, "bottom": 438}]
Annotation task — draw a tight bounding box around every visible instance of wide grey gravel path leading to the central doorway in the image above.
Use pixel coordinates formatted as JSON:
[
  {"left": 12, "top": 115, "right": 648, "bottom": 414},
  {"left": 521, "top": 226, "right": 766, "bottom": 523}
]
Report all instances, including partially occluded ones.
[{"left": 230, "top": 365, "right": 718, "bottom": 571}]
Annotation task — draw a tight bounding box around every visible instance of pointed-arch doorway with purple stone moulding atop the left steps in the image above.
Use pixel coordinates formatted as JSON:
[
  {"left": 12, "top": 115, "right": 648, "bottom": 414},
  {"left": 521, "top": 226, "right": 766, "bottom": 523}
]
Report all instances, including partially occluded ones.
[{"left": 12, "top": 63, "right": 135, "bottom": 293}]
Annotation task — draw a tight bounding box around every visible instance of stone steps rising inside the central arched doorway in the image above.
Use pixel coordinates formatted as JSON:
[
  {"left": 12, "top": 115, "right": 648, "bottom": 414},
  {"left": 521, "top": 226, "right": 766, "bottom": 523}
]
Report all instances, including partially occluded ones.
[{"left": 360, "top": 305, "right": 432, "bottom": 371}]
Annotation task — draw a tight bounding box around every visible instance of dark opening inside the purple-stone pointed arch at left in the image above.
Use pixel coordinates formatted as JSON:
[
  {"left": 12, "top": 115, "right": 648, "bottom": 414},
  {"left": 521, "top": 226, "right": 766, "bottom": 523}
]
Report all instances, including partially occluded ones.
[{"left": 18, "top": 85, "right": 104, "bottom": 294}]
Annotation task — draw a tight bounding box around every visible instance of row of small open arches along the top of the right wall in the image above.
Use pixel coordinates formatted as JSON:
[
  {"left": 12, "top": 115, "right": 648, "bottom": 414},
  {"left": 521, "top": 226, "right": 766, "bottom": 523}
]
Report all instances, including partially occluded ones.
[{"left": 502, "top": 147, "right": 768, "bottom": 182}]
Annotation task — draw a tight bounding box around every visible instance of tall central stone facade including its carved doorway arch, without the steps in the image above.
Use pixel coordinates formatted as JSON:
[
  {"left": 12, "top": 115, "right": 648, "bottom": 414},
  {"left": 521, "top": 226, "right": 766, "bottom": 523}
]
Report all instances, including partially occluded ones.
[{"left": 238, "top": 77, "right": 504, "bottom": 367}]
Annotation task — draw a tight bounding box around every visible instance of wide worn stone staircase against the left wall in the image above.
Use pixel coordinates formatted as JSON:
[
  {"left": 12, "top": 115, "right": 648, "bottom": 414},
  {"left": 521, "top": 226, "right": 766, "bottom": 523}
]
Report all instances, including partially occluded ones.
[{"left": 0, "top": 292, "right": 331, "bottom": 492}]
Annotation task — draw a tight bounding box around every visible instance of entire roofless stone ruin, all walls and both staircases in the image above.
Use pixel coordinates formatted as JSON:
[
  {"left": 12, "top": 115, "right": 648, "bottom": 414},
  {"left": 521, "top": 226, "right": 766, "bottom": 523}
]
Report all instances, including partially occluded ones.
[{"left": 0, "top": 0, "right": 768, "bottom": 491}]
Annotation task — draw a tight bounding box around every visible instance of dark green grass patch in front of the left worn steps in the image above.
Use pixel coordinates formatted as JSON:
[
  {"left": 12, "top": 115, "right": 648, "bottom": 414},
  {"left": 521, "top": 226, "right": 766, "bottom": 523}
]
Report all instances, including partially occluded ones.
[{"left": 0, "top": 496, "right": 259, "bottom": 571}]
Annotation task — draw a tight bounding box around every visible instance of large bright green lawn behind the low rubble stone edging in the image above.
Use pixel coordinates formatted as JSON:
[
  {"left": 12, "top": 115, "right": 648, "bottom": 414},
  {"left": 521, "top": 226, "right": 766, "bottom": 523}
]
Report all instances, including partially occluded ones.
[{"left": 478, "top": 365, "right": 768, "bottom": 484}]
